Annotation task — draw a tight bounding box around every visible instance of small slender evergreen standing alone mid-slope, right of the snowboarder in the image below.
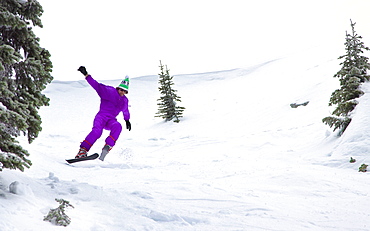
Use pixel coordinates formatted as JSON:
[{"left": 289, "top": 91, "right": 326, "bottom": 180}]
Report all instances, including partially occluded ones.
[{"left": 156, "top": 61, "right": 185, "bottom": 123}]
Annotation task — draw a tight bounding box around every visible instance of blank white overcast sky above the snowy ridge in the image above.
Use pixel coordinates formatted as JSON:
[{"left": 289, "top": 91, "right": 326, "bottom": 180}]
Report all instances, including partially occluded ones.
[{"left": 35, "top": 0, "right": 370, "bottom": 80}]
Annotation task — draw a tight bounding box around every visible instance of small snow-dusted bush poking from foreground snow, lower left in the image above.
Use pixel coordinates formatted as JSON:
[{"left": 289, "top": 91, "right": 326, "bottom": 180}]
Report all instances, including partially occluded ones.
[{"left": 44, "top": 199, "right": 74, "bottom": 226}]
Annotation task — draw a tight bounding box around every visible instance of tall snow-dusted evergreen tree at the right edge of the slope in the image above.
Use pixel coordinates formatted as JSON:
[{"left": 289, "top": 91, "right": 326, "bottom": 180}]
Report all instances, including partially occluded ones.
[{"left": 322, "top": 21, "right": 370, "bottom": 134}]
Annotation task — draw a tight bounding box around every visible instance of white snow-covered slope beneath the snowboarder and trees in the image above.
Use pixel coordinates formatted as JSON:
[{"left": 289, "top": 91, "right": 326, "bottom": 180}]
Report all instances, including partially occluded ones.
[{"left": 0, "top": 46, "right": 370, "bottom": 231}]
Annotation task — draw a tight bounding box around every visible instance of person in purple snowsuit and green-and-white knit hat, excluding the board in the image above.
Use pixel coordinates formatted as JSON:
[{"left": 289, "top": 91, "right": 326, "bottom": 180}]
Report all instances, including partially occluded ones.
[{"left": 75, "top": 66, "right": 131, "bottom": 161}]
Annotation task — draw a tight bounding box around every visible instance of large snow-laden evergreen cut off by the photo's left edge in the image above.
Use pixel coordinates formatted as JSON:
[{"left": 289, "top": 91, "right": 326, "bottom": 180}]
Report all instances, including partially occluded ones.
[{"left": 0, "top": 0, "right": 52, "bottom": 171}]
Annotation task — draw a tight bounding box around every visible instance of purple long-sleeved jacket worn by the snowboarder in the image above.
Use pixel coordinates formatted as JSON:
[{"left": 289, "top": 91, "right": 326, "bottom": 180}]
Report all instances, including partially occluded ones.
[{"left": 86, "top": 75, "right": 130, "bottom": 120}]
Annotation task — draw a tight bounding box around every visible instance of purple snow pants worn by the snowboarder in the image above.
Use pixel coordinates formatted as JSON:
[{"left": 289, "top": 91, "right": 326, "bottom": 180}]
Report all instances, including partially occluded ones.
[{"left": 80, "top": 114, "right": 122, "bottom": 150}]
